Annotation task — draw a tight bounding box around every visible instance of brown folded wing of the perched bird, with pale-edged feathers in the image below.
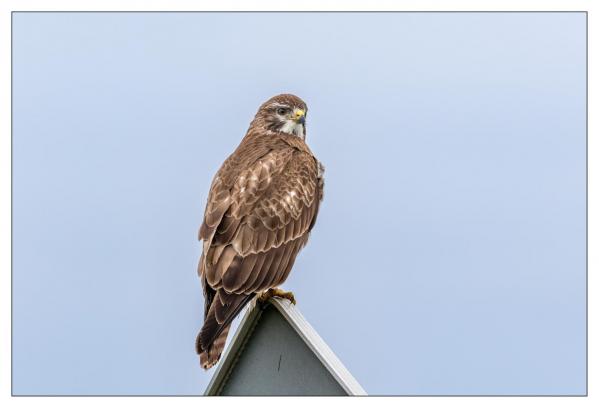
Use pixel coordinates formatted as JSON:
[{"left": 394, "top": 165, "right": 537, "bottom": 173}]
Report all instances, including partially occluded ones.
[{"left": 199, "top": 145, "right": 321, "bottom": 349}]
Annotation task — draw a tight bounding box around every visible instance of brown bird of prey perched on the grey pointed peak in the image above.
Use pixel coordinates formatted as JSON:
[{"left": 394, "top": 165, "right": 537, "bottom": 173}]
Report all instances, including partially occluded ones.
[{"left": 196, "top": 94, "right": 324, "bottom": 369}]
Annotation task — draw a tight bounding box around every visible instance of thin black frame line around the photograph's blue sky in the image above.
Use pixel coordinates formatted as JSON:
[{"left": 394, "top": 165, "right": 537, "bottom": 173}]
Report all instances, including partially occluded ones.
[{"left": 10, "top": 10, "right": 589, "bottom": 398}]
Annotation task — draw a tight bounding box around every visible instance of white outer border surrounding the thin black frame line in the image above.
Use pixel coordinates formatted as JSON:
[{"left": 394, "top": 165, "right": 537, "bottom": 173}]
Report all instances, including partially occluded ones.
[{"left": 0, "top": 0, "right": 599, "bottom": 408}]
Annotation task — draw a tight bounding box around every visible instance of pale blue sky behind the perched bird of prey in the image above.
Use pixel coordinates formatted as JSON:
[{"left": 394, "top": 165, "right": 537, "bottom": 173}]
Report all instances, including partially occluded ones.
[{"left": 13, "top": 13, "right": 586, "bottom": 394}]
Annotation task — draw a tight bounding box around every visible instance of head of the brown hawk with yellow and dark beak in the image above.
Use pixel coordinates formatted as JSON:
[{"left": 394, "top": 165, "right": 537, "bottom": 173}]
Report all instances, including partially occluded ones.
[{"left": 254, "top": 94, "right": 308, "bottom": 139}]
